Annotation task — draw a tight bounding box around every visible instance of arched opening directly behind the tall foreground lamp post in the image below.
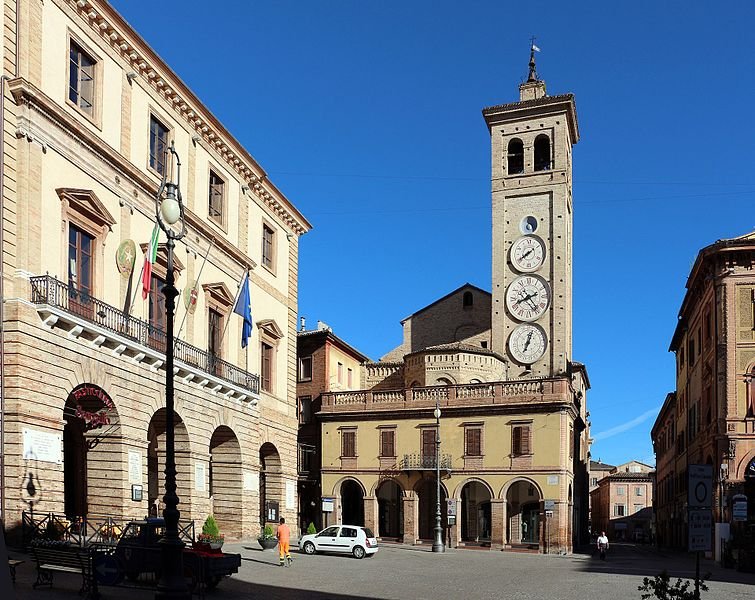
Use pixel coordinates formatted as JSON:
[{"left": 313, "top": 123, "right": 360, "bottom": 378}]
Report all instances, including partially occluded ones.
[{"left": 147, "top": 408, "right": 195, "bottom": 517}]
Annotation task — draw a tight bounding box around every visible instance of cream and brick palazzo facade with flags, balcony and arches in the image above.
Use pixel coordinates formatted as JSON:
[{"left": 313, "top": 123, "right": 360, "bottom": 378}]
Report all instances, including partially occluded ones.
[{"left": 0, "top": 0, "right": 310, "bottom": 537}]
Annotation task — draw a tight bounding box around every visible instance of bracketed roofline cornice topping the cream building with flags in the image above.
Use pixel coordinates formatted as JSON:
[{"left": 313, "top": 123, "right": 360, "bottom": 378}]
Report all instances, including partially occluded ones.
[{"left": 61, "top": 0, "right": 312, "bottom": 235}]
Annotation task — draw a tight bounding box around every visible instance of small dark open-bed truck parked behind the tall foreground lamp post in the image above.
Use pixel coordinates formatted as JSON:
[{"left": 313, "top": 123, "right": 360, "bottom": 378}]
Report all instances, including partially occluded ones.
[{"left": 115, "top": 518, "right": 241, "bottom": 588}]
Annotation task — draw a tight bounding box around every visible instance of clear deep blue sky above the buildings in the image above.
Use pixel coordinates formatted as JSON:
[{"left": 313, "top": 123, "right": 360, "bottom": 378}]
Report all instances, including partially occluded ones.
[{"left": 114, "top": 0, "right": 755, "bottom": 464}]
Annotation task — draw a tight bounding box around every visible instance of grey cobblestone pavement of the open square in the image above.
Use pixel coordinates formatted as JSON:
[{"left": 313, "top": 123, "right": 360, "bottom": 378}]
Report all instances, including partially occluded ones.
[{"left": 7, "top": 542, "right": 755, "bottom": 600}]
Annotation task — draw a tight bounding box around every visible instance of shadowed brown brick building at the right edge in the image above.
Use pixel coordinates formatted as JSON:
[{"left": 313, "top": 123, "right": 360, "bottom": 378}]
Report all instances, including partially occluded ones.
[{"left": 651, "top": 233, "right": 755, "bottom": 556}]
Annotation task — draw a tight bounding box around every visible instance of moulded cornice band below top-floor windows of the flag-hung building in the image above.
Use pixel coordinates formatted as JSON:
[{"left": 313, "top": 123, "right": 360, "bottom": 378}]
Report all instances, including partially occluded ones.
[{"left": 8, "top": 77, "right": 257, "bottom": 269}]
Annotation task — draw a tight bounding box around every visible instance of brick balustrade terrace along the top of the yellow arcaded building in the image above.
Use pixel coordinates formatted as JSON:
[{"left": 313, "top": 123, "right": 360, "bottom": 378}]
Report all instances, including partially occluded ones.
[{"left": 319, "top": 377, "right": 574, "bottom": 415}]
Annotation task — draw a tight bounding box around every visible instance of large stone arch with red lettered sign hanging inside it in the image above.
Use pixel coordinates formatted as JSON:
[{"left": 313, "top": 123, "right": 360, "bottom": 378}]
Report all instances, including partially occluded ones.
[{"left": 64, "top": 383, "right": 126, "bottom": 519}]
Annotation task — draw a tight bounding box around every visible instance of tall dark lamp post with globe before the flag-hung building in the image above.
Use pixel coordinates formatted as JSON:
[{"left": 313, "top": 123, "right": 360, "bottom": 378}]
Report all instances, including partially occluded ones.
[{"left": 155, "top": 143, "right": 191, "bottom": 600}]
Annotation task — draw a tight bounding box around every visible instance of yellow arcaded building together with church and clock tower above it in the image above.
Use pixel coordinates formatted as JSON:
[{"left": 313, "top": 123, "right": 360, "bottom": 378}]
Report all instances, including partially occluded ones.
[{"left": 318, "top": 57, "right": 589, "bottom": 552}]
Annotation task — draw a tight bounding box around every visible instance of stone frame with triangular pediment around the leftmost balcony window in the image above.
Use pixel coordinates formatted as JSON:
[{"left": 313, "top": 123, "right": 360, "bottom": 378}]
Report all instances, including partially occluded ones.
[{"left": 55, "top": 188, "right": 116, "bottom": 298}]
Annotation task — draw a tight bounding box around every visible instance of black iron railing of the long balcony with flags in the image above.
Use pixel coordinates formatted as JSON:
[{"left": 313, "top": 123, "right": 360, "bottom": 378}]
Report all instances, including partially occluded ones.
[{"left": 30, "top": 275, "right": 259, "bottom": 394}]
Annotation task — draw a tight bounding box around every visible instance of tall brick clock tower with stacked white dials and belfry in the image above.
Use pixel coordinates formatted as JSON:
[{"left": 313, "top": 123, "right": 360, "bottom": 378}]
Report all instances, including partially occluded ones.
[{"left": 482, "top": 45, "right": 579, "bottom": 379}]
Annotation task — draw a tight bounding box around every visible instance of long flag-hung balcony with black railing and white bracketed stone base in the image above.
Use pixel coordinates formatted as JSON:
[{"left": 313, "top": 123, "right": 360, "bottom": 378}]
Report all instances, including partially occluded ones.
[{"left": 30, "top": 275, "right": 259, "bottom": 404}]
